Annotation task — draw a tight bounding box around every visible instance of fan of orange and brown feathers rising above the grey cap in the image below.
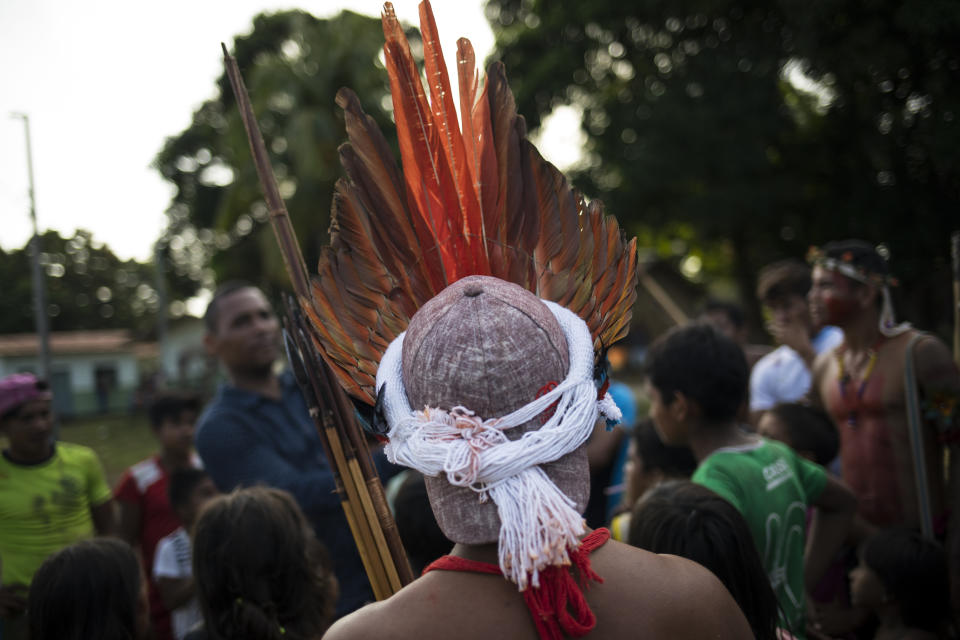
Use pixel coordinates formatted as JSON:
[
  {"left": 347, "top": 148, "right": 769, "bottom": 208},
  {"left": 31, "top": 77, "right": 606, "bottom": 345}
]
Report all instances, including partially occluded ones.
[{"left": 301, "top": 1, "right": 637, "bottom": 404}]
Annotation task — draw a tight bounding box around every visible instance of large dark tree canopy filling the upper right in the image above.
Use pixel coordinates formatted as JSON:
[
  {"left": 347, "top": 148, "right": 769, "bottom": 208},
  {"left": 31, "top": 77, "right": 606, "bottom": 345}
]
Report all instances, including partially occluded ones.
[{"left": 488, "top": 0, "right": 960, "bottom": 338}]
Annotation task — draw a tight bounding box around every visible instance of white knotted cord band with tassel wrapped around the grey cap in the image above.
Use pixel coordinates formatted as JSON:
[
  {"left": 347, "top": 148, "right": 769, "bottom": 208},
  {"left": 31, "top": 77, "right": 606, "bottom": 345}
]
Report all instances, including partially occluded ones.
[{"left": 377, "top": 300, "right": 608, "bottom": 591}]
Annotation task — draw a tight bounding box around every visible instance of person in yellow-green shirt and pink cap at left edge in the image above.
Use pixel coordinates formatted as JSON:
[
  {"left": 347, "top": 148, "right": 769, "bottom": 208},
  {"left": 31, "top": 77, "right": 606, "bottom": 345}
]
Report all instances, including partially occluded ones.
[{"left": 0, "top": 373, "right": 115, "bottom": 640}]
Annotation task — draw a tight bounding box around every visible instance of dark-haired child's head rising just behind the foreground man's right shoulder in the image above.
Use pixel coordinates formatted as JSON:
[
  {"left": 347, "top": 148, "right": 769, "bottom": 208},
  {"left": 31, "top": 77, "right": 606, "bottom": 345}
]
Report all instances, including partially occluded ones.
[{"left": 627, "top": 480, "right": 778, "bottom": 640}]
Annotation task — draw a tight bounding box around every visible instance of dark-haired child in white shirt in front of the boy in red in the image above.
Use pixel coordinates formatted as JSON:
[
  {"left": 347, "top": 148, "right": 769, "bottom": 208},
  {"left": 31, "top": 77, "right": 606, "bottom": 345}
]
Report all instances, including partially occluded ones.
[{"left": 153, "top": 468, "right": 218, "bottom": 640}]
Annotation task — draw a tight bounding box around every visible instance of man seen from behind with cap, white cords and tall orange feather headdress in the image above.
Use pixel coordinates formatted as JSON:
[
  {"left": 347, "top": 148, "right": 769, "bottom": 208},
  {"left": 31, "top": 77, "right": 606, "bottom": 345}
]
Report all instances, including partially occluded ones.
[{"left": 301, "top": 2, "right": 750, "bottom": 640}]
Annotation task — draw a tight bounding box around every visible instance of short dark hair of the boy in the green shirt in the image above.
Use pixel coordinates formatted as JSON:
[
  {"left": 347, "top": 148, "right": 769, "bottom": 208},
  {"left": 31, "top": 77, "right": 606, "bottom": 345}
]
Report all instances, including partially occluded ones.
[{"left": 644, "top": 322, "right": 749, "bottom": 422}]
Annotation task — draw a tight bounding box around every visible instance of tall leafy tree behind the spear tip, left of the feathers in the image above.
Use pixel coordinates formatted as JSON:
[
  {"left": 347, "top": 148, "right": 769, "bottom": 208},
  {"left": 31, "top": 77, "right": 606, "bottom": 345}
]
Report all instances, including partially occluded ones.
[{"left": 155, "top": 11, "right": 402, "bottom": 296}]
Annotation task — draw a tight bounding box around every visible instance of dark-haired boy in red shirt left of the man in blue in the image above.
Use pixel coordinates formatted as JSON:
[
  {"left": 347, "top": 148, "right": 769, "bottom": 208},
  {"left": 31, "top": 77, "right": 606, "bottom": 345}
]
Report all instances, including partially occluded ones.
[{"left": 113, "top": 391, "right": 201, "bottom": 640}]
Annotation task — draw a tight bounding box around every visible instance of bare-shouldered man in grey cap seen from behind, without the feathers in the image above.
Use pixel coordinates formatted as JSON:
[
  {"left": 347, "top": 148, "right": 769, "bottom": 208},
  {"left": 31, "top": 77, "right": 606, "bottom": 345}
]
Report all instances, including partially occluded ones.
[{"left": 326, "top": 276, "right": 750, "bottom": 640}]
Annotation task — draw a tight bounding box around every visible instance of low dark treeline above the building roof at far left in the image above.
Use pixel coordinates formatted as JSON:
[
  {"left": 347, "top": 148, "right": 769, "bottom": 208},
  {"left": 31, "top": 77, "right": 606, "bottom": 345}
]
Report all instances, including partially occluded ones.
[{"left": 0, "top": 230, "right": 192, "bottom": 335}]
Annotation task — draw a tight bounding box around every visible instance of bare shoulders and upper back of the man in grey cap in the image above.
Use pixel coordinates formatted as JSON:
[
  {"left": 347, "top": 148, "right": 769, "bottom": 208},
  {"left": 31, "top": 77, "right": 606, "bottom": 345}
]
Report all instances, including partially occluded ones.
[{"left": 324, "top": 541, "right": 752, "bottom": 640}]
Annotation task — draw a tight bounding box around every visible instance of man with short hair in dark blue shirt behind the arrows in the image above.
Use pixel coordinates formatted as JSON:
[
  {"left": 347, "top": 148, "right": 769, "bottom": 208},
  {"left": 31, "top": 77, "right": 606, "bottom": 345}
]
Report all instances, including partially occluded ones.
[{"left": 196, "top": 282, "right": 392, "bottom": 616}]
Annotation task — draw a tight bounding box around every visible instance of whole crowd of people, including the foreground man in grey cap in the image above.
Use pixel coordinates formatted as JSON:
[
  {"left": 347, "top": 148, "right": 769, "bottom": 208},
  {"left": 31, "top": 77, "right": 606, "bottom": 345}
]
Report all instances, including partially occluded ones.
[{"left": 0, "top": 241, "right": 960, "bottom": 640}]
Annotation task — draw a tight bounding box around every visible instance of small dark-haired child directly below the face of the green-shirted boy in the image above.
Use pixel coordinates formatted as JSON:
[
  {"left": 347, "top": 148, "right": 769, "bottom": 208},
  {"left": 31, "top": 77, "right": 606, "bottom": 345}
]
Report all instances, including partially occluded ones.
[{"left": 610, "top": 418, "right": 697, "bottom": 542}]
